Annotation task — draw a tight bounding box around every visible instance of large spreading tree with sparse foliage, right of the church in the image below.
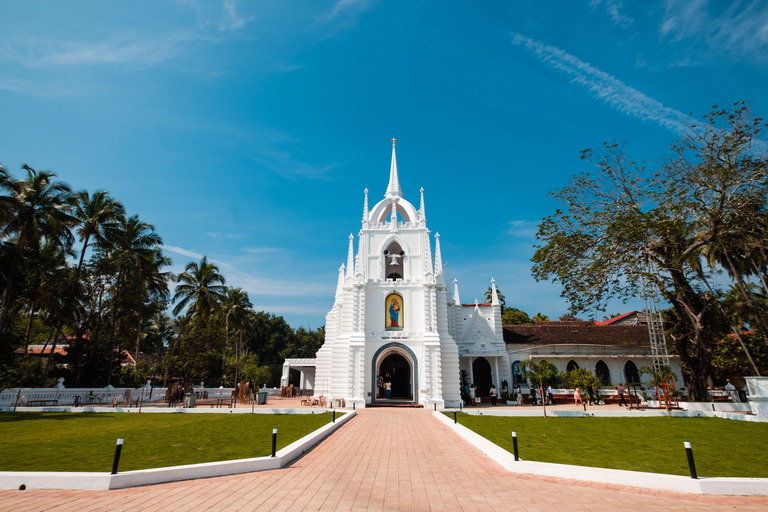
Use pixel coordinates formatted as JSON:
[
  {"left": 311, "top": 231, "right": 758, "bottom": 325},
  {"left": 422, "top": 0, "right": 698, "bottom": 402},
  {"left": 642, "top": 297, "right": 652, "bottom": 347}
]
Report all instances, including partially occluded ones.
[{"left": 533, "top": 103, "right": 768, "bottom": 400}]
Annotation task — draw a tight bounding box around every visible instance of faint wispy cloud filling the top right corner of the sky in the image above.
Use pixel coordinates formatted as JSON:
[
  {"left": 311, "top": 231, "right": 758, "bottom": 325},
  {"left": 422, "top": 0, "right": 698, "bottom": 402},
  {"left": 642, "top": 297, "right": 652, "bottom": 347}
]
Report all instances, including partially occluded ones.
[{"left": 659, "top": 0, "right": 768, "bottom": 65}]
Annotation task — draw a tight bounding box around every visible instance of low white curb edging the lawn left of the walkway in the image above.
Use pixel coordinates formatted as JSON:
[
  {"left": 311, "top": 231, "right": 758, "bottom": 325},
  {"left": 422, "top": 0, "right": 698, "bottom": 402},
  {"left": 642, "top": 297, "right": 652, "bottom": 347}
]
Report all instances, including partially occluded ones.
[{"left": 0, "top": 409, "right": 357, "bottom": 490}]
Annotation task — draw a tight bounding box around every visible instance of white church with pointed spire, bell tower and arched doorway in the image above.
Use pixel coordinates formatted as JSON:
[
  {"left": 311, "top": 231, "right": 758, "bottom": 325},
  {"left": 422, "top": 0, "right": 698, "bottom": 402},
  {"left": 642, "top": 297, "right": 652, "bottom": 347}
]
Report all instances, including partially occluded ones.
[{"left": 283, "top": 139, "right": 511, "bottom": 408}]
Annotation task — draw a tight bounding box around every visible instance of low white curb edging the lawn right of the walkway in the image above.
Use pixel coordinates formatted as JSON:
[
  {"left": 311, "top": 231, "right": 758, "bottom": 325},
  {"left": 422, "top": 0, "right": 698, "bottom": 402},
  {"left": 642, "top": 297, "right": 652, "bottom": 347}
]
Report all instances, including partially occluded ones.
[{"left": 432, "top": 411, "right": 768, "bottom": 496}]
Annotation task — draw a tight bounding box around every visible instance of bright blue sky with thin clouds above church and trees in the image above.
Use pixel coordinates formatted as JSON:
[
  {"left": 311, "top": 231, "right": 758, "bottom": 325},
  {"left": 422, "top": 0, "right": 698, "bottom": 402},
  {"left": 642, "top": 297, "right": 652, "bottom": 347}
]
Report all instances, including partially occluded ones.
[{"left": 0, "top": 0, "right": 768, "bottom": 327}]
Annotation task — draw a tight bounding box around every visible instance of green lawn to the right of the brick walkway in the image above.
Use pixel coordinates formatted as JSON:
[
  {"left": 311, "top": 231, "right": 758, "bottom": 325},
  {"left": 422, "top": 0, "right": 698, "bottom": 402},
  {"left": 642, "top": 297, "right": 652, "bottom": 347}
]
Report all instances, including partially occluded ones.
[{"left": 449, "top": 413, "right": 768, "bottom": 478}]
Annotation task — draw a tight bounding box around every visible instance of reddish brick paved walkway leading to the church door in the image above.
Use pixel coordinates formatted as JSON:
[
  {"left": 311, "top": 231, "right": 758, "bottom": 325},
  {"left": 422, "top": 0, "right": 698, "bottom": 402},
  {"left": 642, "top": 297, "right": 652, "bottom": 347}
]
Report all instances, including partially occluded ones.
[{"left": 0, "top": 409, "right": 768, "bottom": 512}]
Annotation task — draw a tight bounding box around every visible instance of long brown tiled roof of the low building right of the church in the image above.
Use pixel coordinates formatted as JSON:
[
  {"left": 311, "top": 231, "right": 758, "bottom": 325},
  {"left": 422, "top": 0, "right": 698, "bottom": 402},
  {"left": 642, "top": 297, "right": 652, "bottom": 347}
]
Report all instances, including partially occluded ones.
[{"left": 504, "top": 321, "right": 650, "bottom": 347}]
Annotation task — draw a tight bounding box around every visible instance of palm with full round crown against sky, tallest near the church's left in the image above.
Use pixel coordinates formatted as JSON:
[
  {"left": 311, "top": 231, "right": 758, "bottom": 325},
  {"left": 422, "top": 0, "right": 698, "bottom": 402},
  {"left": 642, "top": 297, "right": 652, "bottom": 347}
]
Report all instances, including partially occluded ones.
[{"left": 163, "top": 256, "right": 227, "bottom": 386}]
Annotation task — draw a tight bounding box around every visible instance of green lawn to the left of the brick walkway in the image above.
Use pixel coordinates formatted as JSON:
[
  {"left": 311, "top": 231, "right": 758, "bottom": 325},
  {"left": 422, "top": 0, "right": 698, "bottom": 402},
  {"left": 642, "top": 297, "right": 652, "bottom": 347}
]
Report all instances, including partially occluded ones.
[{"left": 0, "top": 412, "right": 340, "bottom": 472}]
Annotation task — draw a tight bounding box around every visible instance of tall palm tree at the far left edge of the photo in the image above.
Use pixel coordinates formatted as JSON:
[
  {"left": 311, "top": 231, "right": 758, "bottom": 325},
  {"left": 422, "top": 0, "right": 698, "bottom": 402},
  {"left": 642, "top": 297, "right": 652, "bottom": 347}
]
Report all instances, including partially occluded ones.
[{"left": 0, "top": 164, "right": 74, "bottom": 331}]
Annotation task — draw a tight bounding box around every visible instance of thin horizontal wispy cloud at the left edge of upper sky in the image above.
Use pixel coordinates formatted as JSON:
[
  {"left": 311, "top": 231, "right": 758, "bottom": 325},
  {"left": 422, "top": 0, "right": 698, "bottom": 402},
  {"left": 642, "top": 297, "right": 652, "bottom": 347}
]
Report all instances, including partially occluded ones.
[{"left": 0, "top": 32, "right": 202, "bottom": 68}]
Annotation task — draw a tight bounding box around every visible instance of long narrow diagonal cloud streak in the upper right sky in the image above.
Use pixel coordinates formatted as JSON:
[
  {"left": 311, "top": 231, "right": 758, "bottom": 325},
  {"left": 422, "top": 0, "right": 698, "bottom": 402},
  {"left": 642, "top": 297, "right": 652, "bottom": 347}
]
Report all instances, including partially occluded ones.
[{"left": 511, "top": 32, "right": 694, "bottom": 133}]
